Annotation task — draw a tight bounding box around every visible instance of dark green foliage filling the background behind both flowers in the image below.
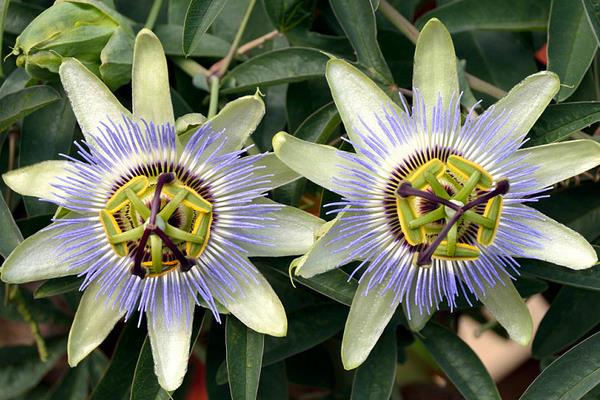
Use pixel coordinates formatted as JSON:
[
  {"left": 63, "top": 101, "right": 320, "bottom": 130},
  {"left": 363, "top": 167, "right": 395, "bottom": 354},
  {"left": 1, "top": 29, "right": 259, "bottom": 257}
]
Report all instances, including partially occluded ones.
[{"left": 0, "top": 0, "right": 600, "bottom": 400}]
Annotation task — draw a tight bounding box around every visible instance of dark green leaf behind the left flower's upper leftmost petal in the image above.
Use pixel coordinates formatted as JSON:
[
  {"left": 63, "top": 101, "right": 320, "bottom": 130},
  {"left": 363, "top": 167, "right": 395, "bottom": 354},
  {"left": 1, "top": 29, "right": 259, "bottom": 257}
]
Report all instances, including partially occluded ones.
[{"left": 19, "top": 86, "right": 76, "bottom": 217}]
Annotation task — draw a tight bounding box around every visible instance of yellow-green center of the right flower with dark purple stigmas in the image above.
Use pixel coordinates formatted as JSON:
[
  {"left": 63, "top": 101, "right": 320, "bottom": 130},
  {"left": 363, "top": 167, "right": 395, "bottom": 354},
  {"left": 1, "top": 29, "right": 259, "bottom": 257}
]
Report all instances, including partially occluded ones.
[{"left": 396, "top": 155, "right": 509, "bottom": 266}]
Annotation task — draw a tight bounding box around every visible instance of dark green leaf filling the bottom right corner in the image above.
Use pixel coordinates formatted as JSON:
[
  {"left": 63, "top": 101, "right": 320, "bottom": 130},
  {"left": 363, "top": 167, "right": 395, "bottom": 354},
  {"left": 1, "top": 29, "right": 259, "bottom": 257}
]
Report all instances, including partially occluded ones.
[{"left": 520, "top": 332, "right": 600, "bottom": 400}]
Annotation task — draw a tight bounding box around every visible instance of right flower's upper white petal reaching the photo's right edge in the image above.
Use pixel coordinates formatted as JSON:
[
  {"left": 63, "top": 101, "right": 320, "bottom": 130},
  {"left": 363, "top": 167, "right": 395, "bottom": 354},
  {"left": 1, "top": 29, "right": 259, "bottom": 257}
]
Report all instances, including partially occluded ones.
[{"left": 515, "top": 140, "right": 600, "bottom": 190}]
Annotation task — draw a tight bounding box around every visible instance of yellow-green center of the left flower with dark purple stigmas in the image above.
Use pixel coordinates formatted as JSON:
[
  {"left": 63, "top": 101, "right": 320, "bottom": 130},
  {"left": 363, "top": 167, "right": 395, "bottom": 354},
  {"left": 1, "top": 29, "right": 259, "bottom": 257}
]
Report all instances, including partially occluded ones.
[{"left": 100, "top": 172, "right": 213, "bottom": 278}]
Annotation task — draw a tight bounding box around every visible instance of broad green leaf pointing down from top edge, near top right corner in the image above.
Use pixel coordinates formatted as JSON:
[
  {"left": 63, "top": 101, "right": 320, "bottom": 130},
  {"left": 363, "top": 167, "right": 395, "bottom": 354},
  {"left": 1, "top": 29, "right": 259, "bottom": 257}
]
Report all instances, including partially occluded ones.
[{"left": 548, "top": 0, "right": 598, "bottom": 102}]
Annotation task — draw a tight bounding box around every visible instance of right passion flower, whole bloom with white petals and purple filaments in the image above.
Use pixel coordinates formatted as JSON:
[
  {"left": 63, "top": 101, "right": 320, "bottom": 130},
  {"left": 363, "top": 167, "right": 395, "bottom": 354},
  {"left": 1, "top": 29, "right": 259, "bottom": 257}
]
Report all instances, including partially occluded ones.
[{"left": 273, "top": 19, "right": 600, "bottom": 369}]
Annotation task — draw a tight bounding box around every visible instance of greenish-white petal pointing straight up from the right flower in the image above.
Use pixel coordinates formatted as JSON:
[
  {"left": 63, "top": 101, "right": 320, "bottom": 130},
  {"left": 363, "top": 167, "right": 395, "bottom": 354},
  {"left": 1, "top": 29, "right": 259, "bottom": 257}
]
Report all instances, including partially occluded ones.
[{"left": 413, "top": 18, "right": 459, "bottom": 126}]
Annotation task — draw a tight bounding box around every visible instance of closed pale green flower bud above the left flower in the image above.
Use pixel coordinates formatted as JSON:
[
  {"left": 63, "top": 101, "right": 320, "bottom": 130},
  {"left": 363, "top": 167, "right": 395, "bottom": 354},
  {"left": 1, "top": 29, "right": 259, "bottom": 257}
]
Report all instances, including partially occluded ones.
[{"left": 12, "top": 0, "right": 134, "bottom": 90}]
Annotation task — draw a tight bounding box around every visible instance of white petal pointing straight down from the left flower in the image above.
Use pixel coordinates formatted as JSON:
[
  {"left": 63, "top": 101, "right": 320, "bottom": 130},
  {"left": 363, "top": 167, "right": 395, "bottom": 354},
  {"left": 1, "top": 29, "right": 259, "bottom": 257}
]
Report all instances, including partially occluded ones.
[{"left": 146, "top": 290, "right": 194, "bottom": 391}]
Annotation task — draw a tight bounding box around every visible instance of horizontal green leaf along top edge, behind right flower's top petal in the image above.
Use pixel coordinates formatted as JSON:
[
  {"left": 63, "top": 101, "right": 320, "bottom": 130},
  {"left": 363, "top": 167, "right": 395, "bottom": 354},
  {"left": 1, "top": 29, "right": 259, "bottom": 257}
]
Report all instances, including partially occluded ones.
[{"left": 416, "top": 0, "right": 550, "bottom": 33}]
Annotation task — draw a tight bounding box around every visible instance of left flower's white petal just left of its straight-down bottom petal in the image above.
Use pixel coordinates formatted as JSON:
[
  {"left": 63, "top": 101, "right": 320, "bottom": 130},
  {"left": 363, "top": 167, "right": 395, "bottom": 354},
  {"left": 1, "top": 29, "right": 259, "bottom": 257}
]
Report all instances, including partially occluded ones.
[{"left": 67, "top": 282, "right": 125, "bottom": 367}]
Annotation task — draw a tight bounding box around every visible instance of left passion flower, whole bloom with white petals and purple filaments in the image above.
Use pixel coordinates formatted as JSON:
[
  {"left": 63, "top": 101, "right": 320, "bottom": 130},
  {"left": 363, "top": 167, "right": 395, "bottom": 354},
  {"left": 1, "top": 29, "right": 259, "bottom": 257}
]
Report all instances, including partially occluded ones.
[{"left": 2, "top": 29, "right": 322, "bottom": 390}]
